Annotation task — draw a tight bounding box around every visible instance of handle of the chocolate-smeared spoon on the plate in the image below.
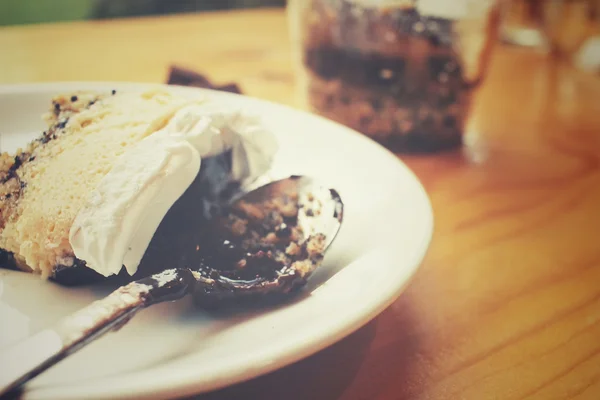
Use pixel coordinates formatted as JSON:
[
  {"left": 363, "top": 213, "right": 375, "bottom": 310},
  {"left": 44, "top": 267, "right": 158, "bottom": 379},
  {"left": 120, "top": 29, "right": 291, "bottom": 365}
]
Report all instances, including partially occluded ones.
[{"left": 0, "top": 269, "right": 193, "bottom": 396}]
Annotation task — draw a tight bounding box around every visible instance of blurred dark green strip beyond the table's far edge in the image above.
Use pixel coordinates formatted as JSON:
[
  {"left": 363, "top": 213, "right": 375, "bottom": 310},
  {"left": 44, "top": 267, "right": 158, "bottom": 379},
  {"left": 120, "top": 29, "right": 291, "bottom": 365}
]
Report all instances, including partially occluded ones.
[{"left": 0, "top": 0, "right": 286, "bottom": 26}]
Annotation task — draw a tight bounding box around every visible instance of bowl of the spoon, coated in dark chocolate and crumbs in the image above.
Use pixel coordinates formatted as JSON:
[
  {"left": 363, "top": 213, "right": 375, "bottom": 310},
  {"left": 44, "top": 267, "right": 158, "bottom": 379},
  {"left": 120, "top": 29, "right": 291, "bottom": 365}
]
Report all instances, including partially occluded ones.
[{"left": 192, "top": 176, "right": 343, "bottom": 308}]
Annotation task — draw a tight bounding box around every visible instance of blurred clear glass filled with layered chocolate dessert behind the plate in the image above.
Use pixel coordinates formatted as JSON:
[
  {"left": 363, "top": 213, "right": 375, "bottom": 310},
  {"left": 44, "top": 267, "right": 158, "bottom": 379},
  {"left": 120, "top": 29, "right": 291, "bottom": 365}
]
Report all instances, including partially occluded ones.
[{"left": 288, "top": 0, "right": 500, "bottom": 152}]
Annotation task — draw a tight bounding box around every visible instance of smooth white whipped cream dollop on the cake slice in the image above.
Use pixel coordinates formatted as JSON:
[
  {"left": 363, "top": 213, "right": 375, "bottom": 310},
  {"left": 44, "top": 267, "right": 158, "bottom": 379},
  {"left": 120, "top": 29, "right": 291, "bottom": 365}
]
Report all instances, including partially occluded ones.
[{"left": 69, "top": 103, "right": 277, "bottom": 276}]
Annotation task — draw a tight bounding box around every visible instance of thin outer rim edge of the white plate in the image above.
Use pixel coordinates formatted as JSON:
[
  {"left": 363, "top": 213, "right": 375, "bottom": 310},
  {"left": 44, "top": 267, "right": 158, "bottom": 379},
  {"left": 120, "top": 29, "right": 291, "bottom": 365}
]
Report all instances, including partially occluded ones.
[{"left": 0, "top": 81, "right": 434, "bottom": 398}]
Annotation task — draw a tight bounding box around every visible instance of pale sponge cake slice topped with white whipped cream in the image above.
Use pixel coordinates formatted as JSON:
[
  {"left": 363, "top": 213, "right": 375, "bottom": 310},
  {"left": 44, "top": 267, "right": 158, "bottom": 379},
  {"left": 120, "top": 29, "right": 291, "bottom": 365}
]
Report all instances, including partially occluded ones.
[{"left": 0, "top": 90, "right": 276, "bottom": 284}]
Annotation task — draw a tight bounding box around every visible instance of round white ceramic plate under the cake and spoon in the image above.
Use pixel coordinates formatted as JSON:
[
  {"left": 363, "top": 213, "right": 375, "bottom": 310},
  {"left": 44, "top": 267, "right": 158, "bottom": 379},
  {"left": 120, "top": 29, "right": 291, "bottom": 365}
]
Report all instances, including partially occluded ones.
[{"left": 0, "top": 83, "right": 433, "bottom": 400}]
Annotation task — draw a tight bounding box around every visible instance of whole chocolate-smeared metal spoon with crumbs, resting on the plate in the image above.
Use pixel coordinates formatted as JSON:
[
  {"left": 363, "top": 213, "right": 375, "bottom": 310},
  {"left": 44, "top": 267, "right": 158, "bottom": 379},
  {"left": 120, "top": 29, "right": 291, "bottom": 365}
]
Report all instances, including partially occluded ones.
[{"left": 0, "top": 176, "right": 343, "bottom": 396}]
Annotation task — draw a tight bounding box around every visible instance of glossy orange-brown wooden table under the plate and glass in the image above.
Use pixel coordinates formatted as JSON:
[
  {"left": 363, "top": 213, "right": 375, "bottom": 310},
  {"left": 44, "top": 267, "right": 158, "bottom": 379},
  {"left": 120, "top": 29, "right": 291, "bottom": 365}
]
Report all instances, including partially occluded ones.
[{"left": 0, "top": 10, "right": 600, "bottom": 400}]
